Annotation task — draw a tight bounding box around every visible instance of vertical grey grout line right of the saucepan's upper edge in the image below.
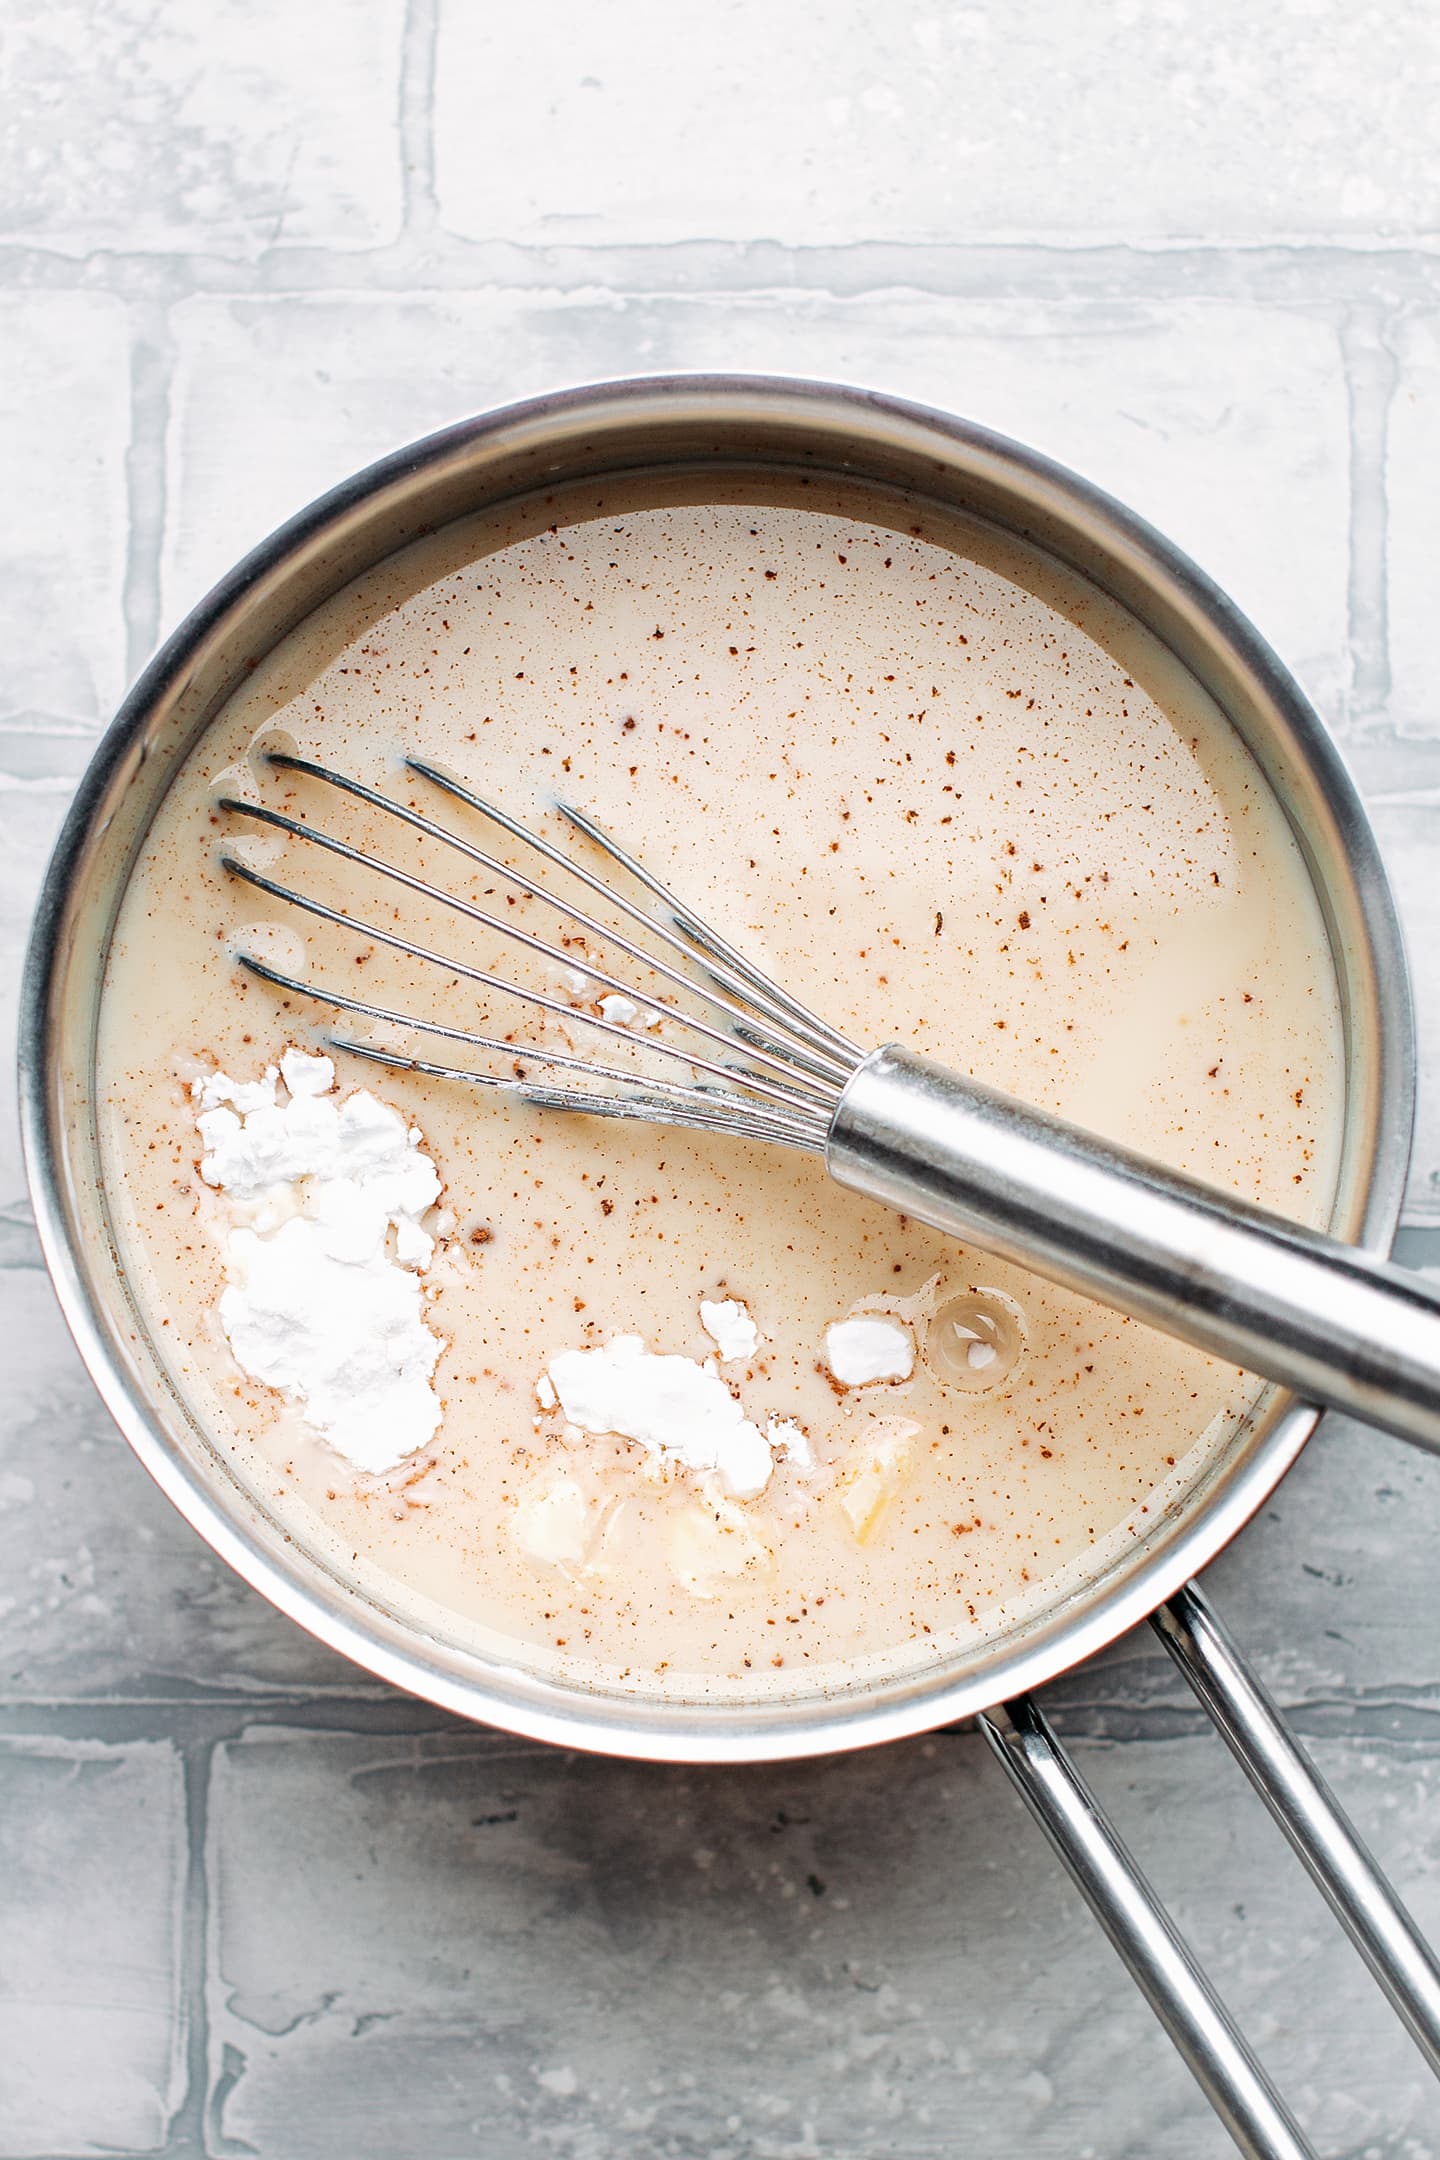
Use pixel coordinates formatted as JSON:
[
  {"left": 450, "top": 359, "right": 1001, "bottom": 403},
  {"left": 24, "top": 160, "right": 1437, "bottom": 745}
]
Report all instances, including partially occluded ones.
[{"left": 1341, "top": 305, "right": 1397, "bottom": 721}]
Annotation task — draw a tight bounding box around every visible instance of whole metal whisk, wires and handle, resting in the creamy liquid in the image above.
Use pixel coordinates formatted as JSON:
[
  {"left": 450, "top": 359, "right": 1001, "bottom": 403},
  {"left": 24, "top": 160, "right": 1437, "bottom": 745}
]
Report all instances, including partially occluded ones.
[{"left": 220, "top": 752, "right": 1440, "bottom": 1452}]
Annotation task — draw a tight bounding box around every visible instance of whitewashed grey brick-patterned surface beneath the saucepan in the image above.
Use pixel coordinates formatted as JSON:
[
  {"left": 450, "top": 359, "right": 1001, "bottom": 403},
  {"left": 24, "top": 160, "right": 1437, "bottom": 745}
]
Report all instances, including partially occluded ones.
[{"left": 0, "top": 0, "right": 1440, "bottom": 2160}]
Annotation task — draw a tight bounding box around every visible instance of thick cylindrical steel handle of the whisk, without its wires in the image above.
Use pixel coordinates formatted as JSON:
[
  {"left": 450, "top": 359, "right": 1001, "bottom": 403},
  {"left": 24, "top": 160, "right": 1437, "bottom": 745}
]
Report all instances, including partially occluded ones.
[{"left": 825, "top": 1043, "right": 1440, "bottom": 1452}]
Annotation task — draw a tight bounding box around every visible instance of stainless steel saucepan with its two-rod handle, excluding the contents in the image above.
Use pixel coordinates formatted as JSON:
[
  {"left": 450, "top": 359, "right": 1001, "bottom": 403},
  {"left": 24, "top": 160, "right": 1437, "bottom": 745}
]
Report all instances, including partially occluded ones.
[{"left": 19, "top": 376, "right": 1440, "bottom": 2160}]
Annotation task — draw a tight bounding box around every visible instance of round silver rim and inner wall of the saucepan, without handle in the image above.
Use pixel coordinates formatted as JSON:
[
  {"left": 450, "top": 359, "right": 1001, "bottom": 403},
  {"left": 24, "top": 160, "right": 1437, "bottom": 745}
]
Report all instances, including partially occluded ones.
[{"left": 19, "top": 376, "right": 1414, "bottom": 1763}]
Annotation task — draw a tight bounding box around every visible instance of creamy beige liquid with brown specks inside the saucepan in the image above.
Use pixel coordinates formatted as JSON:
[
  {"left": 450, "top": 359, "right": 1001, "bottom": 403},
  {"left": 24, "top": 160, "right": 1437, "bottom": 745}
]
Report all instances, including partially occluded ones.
[{"left": 99, "top": 482, "right": 1341, "bottom": 1693}]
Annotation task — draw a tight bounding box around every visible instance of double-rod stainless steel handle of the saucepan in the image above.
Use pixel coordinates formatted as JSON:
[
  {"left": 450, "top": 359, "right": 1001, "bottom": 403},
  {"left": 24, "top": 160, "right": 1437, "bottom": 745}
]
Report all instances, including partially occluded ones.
[{"left": 980, "top": 1583, "right": 1440, "bottom": 2160}]
